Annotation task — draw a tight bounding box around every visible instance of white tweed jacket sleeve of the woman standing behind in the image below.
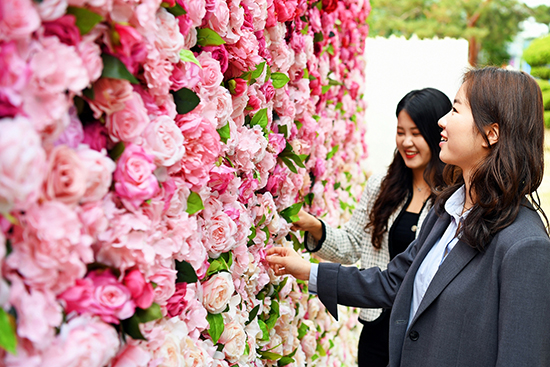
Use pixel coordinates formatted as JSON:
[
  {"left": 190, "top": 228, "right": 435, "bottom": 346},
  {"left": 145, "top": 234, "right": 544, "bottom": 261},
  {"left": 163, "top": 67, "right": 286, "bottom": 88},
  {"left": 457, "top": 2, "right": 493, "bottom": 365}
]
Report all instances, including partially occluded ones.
[{"left": 305, "top": 175, "right": 384, "bottom": 264}]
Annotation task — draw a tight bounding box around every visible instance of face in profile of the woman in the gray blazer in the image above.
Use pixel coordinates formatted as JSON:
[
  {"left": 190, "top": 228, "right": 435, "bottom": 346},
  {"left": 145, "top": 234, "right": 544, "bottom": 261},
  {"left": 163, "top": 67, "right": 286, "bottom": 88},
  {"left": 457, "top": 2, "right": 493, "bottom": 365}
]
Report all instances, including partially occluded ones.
[{"left": 438, "top": 84, "right": 489, "bottom": 175}]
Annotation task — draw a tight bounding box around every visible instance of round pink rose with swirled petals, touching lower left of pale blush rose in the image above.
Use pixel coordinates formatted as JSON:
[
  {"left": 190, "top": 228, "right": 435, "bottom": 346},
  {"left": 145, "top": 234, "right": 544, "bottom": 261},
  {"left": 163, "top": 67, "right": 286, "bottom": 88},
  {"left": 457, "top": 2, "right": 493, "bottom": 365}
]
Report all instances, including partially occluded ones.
[{"left": 114, "top": 144, "right": 159, "bottom": 208}]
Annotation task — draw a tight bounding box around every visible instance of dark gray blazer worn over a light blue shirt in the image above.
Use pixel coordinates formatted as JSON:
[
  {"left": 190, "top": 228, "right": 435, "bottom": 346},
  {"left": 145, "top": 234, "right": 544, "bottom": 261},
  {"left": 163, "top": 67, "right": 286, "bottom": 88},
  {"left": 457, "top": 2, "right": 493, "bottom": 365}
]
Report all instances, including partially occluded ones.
[{"left": 317, "top": 204, "right": 550, "bottom": 367}]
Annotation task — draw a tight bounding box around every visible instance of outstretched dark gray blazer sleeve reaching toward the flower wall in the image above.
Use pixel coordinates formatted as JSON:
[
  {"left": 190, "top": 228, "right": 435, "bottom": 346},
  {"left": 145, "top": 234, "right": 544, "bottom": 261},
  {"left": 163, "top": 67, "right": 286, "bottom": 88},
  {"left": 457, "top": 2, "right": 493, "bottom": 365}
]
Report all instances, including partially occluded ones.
[{"left": 317, "top": 233, "right": 421, "bottom": 320}]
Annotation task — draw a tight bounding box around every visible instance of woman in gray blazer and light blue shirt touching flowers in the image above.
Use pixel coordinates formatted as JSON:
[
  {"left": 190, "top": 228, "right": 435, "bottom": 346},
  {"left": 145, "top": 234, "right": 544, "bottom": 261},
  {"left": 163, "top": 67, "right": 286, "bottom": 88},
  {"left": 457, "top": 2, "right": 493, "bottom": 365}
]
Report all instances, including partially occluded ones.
[{"left": 268, "top": 68, "right": 550, "bottom": 367}]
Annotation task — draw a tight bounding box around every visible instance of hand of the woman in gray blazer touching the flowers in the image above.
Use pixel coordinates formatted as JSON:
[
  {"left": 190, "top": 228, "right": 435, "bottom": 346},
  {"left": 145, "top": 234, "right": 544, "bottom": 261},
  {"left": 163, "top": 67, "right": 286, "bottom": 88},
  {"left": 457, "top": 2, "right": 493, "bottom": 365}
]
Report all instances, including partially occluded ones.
[{"left": 266, "top": 247, "right": 311, "bottom": 280}]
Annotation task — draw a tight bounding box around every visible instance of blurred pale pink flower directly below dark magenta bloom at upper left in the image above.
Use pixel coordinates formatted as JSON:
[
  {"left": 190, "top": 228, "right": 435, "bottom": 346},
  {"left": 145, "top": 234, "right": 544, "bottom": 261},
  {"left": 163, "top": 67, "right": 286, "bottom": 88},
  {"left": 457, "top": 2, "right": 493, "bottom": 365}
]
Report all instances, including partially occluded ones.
[{"left": 29, "top": 37, "right": 90, "bottom": 94}]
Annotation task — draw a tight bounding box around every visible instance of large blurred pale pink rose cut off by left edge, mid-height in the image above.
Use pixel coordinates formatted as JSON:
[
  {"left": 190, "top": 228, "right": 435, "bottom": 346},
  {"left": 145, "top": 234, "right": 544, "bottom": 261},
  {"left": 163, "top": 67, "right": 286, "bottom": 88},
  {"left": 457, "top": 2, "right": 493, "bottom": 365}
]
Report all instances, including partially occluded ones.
[{"left": 0, "top": 117, "right": 46, "bottom": 213}]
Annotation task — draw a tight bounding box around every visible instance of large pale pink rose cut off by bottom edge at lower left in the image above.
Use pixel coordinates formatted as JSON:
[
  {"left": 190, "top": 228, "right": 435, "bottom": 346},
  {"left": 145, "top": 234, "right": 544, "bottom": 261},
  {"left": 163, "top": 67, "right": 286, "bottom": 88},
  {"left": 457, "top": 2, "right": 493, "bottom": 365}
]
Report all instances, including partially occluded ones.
[{"left": 42, "top": 316, "right": 120, "bottom": 367}]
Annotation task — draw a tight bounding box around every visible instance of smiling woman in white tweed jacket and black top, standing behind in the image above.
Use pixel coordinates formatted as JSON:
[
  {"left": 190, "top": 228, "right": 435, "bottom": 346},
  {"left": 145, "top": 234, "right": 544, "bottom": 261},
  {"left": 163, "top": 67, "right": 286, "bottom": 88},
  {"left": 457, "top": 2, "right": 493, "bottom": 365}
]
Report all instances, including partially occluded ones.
[{"left": 293, "top": 88, "right": 451, "bottom": 367}]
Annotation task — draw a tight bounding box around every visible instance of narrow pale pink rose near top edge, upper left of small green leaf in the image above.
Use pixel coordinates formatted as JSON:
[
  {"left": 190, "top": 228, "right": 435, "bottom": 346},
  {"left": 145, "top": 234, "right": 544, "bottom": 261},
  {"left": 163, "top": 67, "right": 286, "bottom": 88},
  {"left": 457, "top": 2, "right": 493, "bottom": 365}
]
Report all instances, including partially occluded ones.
[{"left": 155, "top": 8, "right": 184, "bottom": 63}]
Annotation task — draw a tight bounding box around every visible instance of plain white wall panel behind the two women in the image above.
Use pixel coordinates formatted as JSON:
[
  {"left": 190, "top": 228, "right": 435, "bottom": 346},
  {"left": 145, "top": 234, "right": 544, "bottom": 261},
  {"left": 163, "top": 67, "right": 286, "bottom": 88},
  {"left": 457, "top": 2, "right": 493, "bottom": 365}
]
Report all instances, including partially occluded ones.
[{"left": 364, "top": 37, "right": 469, "bottom": 173}]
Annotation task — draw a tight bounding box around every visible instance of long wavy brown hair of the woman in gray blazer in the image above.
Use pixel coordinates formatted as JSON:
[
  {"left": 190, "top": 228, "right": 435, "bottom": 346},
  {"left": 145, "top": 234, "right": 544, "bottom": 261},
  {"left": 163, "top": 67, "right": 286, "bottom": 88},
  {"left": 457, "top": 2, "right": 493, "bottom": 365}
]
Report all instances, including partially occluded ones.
[{"left": 435, "top": 67, "right": 548, "bottom": 251}]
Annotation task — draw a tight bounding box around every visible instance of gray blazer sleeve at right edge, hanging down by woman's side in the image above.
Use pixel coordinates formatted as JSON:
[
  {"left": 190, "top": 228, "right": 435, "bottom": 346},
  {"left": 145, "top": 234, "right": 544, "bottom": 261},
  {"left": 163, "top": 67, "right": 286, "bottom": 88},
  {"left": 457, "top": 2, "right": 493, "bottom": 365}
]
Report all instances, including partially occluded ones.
[{"left": 497, "top": 237, "right": 550, "bottom": 366}]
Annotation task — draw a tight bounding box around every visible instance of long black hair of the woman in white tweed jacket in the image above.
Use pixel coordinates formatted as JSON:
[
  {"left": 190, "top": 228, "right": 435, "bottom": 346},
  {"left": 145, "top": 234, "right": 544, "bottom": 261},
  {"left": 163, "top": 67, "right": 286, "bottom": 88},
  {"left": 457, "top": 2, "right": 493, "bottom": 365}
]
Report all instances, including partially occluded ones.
[{"left": 365, "top": 88, "right": 452, "bottom": 249}]
